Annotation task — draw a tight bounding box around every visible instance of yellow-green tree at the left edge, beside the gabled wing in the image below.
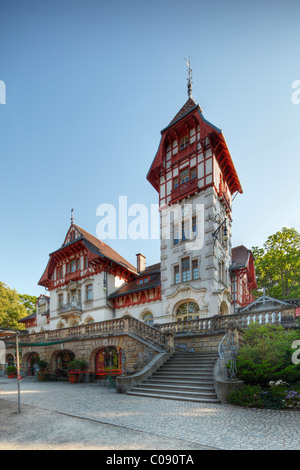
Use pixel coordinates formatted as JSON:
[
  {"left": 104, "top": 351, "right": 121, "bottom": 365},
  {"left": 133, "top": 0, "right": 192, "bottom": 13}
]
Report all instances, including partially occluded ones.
[{"left": 0, "top": 282, "right": 28, "bottom": 330}]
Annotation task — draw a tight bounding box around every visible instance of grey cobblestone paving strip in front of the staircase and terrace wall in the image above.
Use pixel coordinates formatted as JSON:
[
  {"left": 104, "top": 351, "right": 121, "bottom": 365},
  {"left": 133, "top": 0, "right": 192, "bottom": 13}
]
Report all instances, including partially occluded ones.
[{"left": 0, "top": 377, "right": 300, "bottom": 450}]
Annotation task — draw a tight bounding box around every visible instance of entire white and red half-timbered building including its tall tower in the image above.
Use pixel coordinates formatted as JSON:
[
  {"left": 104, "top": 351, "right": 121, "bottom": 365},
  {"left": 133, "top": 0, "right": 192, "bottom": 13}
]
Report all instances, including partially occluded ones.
[{"left": 24, "top": 92, "right": 256, "bottom": 332}]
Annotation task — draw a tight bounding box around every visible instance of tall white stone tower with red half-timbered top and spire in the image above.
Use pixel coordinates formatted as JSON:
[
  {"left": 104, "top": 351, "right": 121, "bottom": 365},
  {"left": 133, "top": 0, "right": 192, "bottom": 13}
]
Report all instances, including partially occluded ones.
[{"left": 147, "top": 73, "right": 242, "bottom": 322}]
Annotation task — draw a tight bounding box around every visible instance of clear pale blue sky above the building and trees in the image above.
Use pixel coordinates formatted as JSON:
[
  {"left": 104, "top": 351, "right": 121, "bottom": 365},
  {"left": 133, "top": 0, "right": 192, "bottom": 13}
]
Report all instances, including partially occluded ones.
[{"left": 0, "top": 0, "right": 300, "bottom": 295}]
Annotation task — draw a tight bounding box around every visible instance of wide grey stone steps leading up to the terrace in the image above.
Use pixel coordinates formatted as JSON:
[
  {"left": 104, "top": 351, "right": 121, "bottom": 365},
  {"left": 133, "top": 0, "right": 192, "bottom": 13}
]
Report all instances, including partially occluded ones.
[{"left": 127, "top": 352, "right": 219, "bottom": 403}]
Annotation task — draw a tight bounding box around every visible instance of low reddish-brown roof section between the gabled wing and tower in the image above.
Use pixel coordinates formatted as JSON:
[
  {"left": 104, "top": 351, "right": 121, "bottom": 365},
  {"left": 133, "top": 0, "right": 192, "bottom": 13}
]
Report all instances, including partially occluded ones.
[{"left": 108, "top": 263, "right": 160, "bottom": 299}]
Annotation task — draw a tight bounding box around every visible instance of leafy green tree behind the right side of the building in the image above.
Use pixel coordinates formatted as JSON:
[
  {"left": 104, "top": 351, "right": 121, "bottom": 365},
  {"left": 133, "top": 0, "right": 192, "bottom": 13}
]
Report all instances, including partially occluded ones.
[{"left": 252, "top": 227, "right": 300, "bottom": 299}]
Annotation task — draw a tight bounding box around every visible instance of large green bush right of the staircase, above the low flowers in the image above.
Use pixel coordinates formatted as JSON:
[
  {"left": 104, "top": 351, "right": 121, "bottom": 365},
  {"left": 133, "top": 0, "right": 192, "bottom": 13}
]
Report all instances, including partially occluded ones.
[{"left": 236, "top": 324, "right": 300, "bottom": 386}]
